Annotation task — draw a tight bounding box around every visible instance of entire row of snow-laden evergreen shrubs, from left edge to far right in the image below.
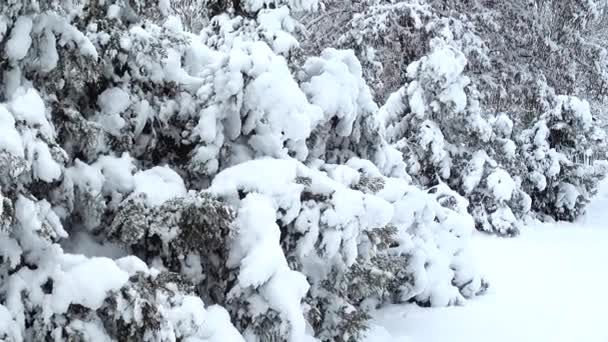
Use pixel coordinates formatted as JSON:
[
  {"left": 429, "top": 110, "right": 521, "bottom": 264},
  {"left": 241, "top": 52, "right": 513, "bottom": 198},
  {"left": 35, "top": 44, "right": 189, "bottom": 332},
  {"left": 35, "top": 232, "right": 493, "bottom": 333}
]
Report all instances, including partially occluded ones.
[{"left": 0, "top": 0, "right": 603, "bottom": 342}]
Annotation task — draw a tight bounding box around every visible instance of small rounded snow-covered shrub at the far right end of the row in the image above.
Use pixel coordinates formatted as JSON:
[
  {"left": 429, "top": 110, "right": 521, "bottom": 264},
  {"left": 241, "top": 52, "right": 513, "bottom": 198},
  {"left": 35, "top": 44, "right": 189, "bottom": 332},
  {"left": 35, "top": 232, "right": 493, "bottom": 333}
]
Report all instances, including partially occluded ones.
[{"left": 521, "top": 96, "right": 606, "bottom": 221}]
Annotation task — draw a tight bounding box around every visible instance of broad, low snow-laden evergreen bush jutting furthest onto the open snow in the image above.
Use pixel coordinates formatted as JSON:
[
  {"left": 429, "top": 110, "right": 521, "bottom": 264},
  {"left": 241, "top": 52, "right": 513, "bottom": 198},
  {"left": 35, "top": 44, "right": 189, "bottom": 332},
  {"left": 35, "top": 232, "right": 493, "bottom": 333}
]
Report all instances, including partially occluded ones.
[{"left": 210, "top": 159, "right": 486, "bottom": 341}]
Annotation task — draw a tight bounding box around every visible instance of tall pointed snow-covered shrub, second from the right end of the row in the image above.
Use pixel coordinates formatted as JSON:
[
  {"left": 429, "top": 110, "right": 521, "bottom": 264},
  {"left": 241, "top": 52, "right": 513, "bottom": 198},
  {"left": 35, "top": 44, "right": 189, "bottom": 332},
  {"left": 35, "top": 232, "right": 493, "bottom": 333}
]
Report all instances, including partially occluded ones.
[{"left": 379, "top": 41, "right": 529, "bottom": 235}]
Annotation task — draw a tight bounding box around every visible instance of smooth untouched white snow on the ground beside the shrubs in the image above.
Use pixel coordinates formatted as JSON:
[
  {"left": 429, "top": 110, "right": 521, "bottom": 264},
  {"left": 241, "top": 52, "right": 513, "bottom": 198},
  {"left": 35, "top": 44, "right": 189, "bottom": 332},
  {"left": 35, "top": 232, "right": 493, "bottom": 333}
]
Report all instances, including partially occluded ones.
[{"left": 368, "top": 182, "right": 608, "bottom": 342}]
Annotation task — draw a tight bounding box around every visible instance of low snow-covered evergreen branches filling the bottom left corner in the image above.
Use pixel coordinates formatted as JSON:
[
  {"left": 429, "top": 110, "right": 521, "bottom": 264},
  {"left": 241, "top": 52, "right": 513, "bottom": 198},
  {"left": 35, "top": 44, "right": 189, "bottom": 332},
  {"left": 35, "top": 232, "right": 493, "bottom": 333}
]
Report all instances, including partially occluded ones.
[{"left": 0, "top": 245, "right": 244, "bottom": 341}]
